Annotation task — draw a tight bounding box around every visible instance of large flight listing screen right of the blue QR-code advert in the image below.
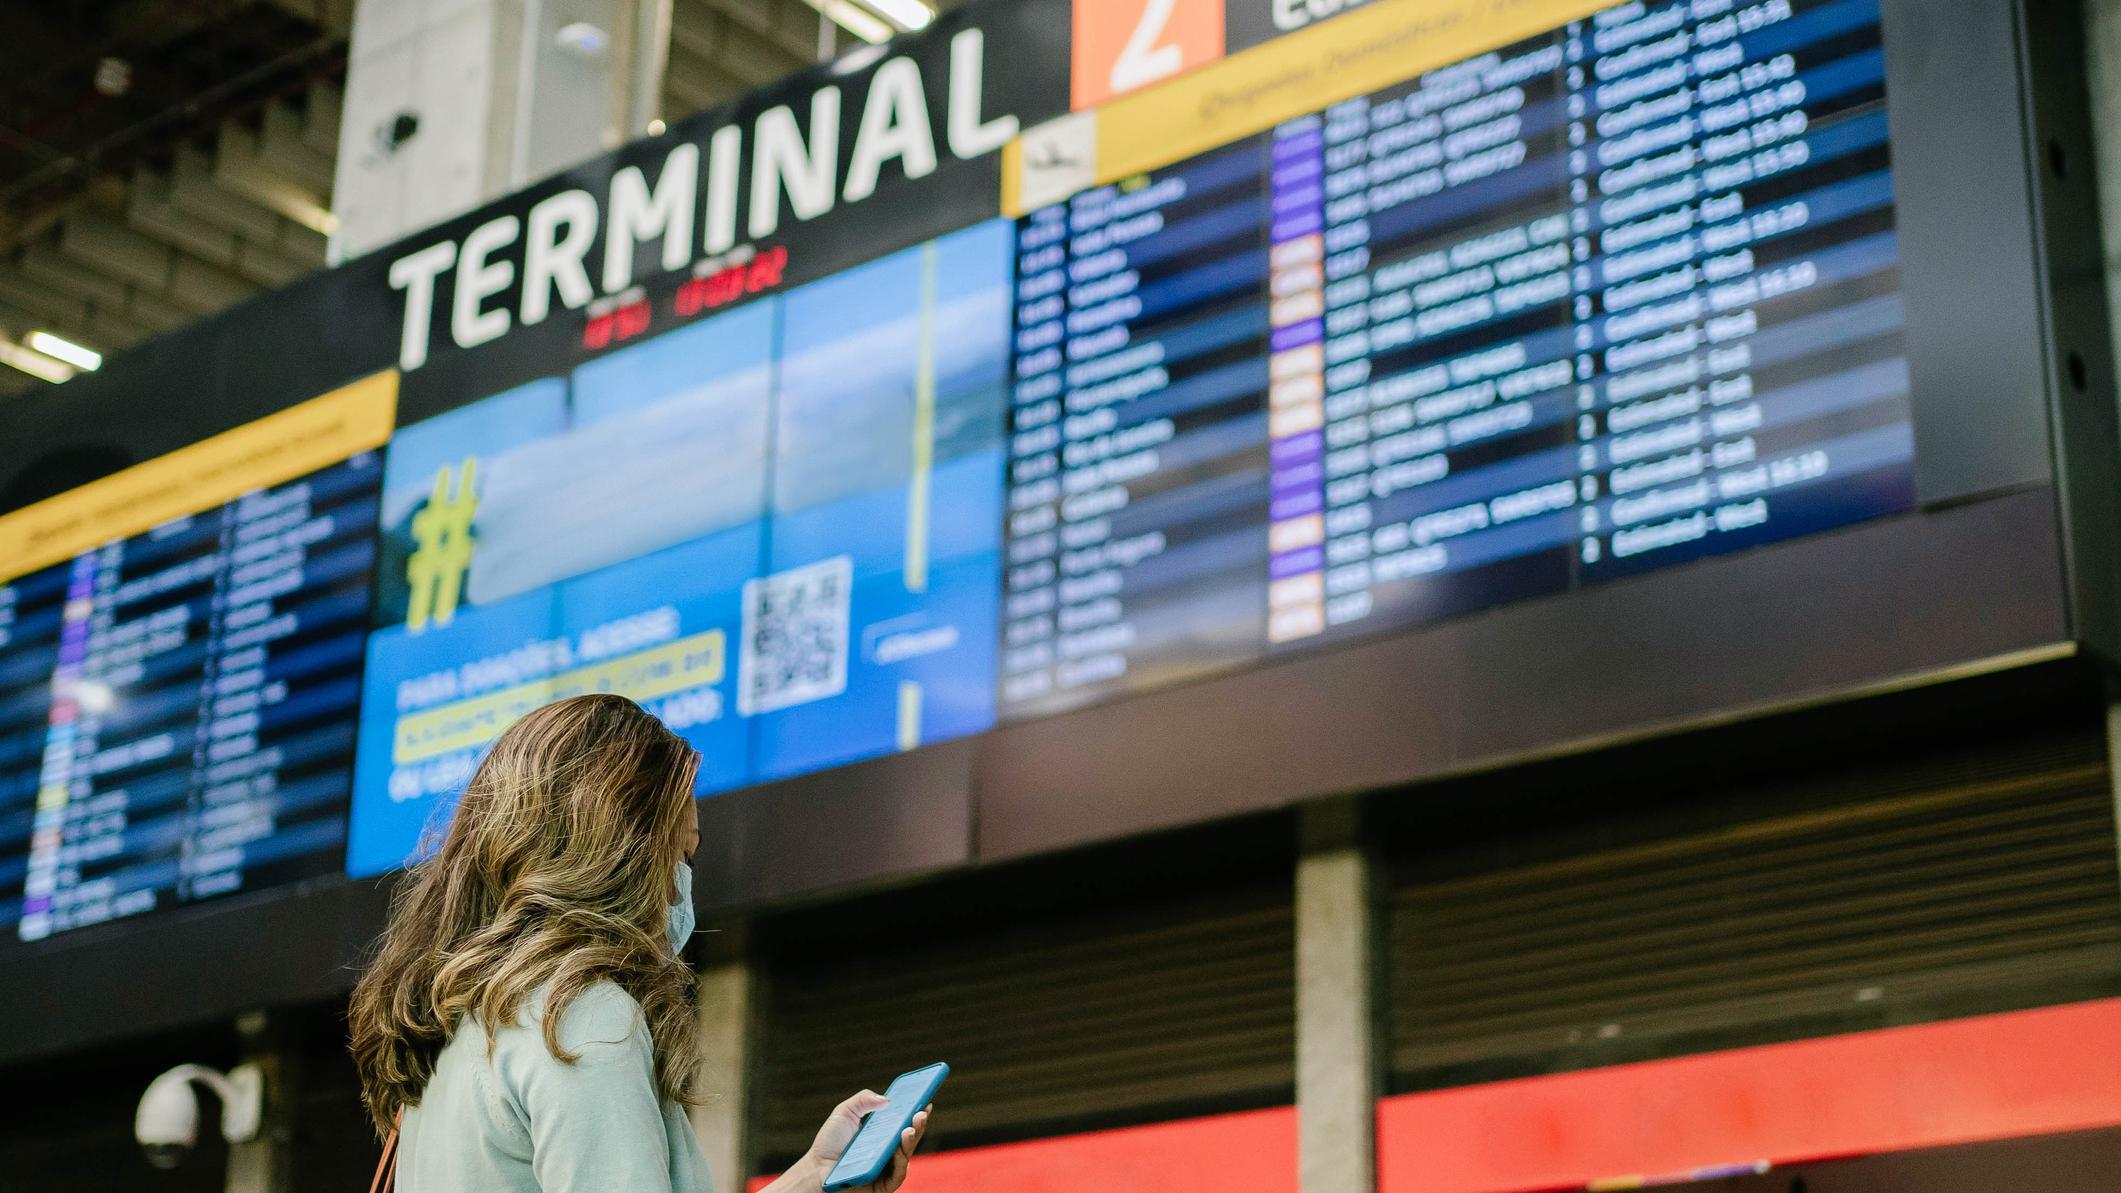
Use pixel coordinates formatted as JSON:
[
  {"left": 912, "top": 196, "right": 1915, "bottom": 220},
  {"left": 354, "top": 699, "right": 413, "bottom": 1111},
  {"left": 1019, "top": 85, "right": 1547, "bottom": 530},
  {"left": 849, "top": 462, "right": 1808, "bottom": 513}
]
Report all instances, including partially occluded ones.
[{"left": 1001, "top": 0, "right": 1915, "bottom": 704}]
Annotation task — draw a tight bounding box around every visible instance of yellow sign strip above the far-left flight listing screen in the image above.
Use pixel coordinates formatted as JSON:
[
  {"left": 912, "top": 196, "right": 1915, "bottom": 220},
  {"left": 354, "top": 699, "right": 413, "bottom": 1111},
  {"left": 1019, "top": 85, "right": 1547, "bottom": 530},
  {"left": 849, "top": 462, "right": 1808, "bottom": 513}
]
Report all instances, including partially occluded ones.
[{"left": 0, "top": 369, "right": 399, "bottom": 580}]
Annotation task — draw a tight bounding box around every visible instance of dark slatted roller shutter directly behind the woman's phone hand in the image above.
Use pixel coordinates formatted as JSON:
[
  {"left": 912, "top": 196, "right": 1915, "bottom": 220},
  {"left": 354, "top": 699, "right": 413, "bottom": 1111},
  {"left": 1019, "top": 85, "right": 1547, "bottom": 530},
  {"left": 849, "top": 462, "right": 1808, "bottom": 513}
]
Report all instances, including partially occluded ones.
[{"left": 757, "top": 883, "right": 1296, "bottom": 1161}]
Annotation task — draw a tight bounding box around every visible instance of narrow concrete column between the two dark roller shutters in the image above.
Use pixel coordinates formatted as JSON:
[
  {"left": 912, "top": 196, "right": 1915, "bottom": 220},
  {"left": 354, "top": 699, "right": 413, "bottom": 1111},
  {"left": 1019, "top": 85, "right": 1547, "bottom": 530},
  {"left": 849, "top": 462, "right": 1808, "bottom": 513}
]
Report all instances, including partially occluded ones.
[{"left": 1296, "top": 800, "right": 1383, "bottom": 1193}]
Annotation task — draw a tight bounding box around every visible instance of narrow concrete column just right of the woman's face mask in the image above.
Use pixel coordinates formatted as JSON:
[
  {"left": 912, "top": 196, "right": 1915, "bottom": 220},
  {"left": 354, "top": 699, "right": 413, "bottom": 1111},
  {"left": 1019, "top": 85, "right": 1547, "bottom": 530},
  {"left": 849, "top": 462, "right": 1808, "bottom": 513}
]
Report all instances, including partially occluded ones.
[{"left": 691, "top": 928, "right": 764, "bottom": 1189}]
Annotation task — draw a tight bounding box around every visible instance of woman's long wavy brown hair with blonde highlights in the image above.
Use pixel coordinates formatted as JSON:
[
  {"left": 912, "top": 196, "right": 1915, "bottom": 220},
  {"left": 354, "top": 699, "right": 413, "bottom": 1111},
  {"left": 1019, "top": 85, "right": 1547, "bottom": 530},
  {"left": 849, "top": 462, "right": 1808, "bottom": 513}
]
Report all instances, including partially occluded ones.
[{"left": 348, "top": 694, "right": 700, "bottom": 1131}]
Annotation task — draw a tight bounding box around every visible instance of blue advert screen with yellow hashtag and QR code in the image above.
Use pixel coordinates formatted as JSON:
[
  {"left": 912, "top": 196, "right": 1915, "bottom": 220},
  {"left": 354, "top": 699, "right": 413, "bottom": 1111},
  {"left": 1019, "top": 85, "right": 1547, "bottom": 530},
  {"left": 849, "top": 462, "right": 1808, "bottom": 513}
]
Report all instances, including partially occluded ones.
[{"left": 348, "top": 221, "right": 1014, "bottom": 875}]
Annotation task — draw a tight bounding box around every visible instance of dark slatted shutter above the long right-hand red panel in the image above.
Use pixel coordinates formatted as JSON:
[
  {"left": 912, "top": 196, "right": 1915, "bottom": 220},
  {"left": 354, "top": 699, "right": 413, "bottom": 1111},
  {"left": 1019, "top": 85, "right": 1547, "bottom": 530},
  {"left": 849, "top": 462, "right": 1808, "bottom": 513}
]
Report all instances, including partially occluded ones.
[{"left": 1385, "top": 662, "right": 2121, "bottom": 1091}]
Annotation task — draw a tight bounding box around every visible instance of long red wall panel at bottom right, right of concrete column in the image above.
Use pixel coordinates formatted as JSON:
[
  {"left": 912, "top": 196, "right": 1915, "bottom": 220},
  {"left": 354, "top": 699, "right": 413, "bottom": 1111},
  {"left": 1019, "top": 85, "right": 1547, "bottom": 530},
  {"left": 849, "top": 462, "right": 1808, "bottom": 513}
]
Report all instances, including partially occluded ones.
[{"left": 1379, "top": 1000, "right": 2121, "bottom": 1193}]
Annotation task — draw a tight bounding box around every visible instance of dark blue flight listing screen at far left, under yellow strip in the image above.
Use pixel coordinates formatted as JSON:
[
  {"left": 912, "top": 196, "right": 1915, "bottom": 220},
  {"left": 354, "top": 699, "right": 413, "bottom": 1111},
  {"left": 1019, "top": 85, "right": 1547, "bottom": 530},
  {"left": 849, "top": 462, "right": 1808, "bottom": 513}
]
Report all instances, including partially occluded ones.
[{"left": 0, "top": 452, "right": 382, "bottom": 940}]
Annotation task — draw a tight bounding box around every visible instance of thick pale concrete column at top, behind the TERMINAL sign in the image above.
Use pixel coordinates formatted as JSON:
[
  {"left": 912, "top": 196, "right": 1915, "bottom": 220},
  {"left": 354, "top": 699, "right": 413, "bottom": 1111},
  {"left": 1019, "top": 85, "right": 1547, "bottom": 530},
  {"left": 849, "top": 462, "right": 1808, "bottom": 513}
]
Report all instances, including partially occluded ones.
[{"left": 331, "top": 0, "right": 670, "bottom": 261}]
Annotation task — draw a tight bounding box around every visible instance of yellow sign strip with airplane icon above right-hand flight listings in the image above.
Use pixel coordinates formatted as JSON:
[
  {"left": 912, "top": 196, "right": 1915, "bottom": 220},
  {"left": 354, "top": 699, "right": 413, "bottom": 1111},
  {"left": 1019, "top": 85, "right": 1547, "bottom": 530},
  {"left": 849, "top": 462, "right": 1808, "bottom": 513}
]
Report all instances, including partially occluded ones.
[{"left": 1003, "top": 0, "right": 1612, "bottom": 214}]
